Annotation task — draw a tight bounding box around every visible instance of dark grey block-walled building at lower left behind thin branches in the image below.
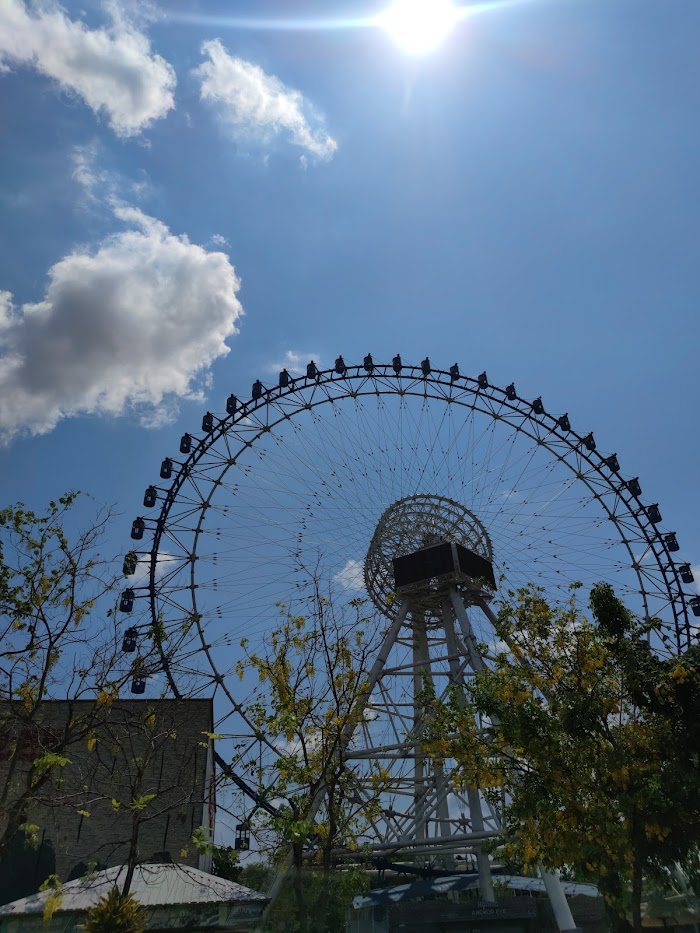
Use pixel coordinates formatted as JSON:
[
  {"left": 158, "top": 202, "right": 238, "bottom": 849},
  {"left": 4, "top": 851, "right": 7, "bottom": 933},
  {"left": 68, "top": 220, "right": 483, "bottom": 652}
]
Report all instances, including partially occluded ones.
[{"left": 0, "top": 699, "right": 215, "bottom": 903}]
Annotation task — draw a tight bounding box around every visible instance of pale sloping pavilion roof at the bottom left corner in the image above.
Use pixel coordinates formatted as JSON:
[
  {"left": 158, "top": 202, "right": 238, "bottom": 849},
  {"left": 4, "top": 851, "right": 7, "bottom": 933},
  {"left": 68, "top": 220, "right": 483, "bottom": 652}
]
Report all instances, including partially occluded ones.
[{"left": 0, "top": 863, "right": 268, "bottom": 918}]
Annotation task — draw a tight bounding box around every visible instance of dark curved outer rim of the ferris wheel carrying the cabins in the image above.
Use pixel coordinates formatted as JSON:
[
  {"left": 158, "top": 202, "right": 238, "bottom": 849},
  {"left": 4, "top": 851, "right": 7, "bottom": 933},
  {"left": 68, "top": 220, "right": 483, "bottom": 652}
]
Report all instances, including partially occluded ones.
[{"left": 124, "top": 362, "right": 692, "bottom": 712}]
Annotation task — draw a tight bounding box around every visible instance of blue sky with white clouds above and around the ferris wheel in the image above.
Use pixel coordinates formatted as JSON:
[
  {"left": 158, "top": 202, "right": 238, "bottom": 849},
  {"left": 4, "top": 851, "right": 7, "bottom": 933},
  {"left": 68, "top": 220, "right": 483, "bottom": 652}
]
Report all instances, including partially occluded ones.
[{"left": 0, "top": 0, "right": 700, "bottom": 584}]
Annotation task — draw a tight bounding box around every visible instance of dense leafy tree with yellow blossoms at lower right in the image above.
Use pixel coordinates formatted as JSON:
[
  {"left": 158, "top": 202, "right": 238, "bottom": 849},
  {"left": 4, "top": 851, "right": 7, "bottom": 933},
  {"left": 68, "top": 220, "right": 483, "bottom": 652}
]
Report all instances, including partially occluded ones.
[{"left": 426, "top": 584, "right": 700, "bottom": 933}]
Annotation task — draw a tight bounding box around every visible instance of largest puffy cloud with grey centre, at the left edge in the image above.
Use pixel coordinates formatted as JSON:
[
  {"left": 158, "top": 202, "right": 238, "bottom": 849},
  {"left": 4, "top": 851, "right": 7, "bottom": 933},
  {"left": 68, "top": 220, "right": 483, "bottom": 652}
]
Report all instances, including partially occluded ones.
[{"left": 0, "top": 207, "right": 242, "bottom": 441}]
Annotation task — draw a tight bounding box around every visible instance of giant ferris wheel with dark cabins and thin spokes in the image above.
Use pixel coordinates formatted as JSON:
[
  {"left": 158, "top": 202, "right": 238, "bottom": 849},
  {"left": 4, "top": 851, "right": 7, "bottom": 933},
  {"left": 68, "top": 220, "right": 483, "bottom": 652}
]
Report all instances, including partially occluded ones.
[{"left": 120, "top": 354, "right": 700, "bottom": 872}]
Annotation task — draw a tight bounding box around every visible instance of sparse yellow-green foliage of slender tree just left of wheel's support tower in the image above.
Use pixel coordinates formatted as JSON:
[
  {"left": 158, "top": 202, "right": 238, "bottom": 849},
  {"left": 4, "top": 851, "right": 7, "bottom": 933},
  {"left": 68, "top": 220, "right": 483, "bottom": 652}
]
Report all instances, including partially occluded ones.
[{"left": 238, "top": 588, "right": 385, "bottom": 869}]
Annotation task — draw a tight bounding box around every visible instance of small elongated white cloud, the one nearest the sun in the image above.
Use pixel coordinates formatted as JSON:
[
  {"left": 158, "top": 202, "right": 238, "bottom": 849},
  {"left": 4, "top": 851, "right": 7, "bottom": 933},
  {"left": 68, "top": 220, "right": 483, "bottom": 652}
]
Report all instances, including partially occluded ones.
[{"left": 194, "top": 39, "right": 338, "bottom": 164}]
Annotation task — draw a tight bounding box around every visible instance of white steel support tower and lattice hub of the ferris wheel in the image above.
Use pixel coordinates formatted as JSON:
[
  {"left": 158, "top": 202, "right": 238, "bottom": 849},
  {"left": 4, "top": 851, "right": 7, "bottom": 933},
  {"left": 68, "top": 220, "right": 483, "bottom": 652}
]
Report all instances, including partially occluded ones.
[{"left": 346, "top": 496, "right": 576, "bottom": 931}]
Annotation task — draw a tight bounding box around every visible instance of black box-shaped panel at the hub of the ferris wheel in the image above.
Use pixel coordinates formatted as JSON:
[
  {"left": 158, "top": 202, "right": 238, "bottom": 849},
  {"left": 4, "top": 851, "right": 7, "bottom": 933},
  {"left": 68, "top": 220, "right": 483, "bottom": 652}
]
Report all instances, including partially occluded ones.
[{"left": 393, "top": 541, "right": 496, "bottom": 593}]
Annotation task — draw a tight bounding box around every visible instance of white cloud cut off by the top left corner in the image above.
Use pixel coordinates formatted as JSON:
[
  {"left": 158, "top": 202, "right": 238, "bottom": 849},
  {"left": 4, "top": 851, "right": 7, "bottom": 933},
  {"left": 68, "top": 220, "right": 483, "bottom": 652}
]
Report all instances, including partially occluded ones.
[{"left": 0, "top": 0, "right": 175, "bottom": 136}]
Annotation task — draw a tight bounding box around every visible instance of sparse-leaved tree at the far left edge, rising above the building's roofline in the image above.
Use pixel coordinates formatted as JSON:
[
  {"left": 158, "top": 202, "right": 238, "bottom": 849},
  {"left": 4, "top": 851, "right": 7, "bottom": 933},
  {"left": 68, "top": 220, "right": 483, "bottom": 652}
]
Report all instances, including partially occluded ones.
[{"left": 0, "top": 494, "right": 128, "bottom": 858}]
